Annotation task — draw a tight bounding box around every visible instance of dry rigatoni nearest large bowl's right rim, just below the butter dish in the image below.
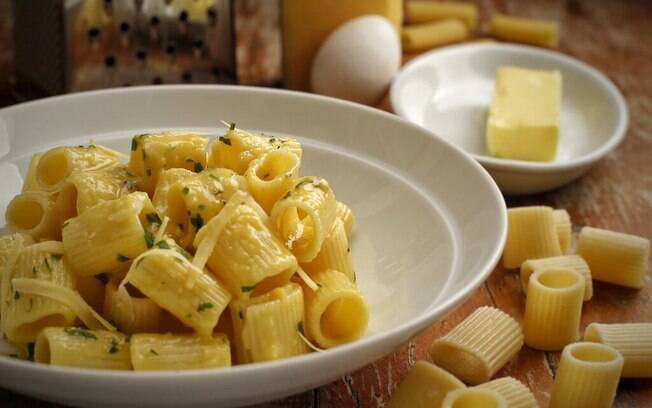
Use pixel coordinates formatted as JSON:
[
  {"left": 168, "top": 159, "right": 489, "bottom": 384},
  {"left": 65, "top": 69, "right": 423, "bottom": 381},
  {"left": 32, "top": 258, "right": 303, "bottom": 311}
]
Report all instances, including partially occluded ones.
[{"left": 503, "top": 206, "right": 561, "bottom": 268}]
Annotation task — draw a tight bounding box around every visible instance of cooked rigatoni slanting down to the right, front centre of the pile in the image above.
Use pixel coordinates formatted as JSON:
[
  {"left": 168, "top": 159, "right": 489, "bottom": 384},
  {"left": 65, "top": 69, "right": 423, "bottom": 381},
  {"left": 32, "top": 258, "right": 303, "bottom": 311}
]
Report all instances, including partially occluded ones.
[{"left": 126, "top": 249, "right": 231, "bottom": 335}]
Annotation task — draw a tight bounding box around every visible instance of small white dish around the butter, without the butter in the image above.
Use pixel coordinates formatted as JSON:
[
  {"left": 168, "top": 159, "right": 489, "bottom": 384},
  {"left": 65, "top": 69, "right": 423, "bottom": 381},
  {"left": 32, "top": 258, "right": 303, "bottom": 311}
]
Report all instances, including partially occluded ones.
[{"left": 390, "top": 43, "right": 628, "bottom": 194}]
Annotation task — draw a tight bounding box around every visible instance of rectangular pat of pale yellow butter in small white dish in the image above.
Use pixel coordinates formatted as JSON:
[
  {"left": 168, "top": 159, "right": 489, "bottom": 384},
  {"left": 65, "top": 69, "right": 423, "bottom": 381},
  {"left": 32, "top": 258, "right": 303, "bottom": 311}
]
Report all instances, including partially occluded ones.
[{"left": 487, "top": 67, "right": 561, "bottom": 161}]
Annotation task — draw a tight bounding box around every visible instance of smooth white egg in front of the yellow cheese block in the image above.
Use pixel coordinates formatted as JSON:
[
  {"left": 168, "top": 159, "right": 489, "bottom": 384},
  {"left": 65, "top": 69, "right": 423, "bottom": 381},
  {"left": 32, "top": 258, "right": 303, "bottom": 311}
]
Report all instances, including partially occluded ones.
[{"left": 310, "top": 15, "right": 401, "bottom": 105}]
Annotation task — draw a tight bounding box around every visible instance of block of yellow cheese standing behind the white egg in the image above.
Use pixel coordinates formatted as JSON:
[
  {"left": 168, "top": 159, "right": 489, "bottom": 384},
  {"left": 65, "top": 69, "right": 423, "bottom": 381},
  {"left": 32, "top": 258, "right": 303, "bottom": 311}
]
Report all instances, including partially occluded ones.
[{"left": 281, "top": 0, "right": 403, "bottom": 91}]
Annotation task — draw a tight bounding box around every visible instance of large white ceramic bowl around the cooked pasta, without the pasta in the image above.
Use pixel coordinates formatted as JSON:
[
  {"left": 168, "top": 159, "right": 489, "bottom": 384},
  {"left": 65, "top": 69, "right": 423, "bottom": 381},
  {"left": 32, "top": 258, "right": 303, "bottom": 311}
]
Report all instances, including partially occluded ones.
[{"left": 0, "top": 86, "right": 506, "bottom": 407}]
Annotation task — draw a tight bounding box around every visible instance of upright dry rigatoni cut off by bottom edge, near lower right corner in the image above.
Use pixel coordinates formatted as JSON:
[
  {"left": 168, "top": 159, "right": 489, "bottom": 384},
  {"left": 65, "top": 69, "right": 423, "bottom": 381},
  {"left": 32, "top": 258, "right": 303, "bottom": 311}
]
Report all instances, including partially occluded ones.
[{"left": 550, "top": 343, "right": 623, "bottom": 408}]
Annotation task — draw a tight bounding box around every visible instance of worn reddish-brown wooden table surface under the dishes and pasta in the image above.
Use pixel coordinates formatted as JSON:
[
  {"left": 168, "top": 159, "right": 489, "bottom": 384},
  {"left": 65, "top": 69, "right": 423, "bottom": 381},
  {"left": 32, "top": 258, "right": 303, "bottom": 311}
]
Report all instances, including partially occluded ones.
[{"left": 0, "top": 0, "right": 652, "bottom": 408}]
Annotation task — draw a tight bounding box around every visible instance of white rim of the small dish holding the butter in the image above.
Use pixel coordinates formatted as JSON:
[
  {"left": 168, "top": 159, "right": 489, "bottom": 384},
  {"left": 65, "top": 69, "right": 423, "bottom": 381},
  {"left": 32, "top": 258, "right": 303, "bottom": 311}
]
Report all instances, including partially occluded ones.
[{"left": 389, "top": 42, "right": 629, "bottom": 173}]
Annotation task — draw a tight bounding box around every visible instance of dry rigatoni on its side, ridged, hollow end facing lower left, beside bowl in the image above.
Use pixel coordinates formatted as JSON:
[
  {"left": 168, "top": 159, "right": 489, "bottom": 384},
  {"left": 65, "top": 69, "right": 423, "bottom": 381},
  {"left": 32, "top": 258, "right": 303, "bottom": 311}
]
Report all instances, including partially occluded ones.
[{"left": 430, "top": 306, "right": 523, "bottom": 385}]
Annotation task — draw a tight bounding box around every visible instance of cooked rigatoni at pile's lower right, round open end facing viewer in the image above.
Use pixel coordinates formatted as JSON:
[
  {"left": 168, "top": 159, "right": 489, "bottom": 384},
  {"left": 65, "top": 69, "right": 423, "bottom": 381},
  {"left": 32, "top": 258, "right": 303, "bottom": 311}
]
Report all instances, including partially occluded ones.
[{"left": 303, "top": 270, "right": 369, "bottom": 348}]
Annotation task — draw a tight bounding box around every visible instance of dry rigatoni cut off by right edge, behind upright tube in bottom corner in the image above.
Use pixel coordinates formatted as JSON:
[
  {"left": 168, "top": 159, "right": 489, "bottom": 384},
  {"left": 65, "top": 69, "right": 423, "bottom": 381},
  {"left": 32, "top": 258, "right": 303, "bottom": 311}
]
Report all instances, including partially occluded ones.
[{"left": 584, "top": 323, "right": 652, "bottom": 378}]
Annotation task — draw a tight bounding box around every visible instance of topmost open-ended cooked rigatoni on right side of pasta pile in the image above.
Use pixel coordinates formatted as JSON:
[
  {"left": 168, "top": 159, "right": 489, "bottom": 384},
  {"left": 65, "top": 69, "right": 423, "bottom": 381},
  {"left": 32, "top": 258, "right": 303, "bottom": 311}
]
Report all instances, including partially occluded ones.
[{"left": 245, "top": 149, "right": 300, "bottom": 213}]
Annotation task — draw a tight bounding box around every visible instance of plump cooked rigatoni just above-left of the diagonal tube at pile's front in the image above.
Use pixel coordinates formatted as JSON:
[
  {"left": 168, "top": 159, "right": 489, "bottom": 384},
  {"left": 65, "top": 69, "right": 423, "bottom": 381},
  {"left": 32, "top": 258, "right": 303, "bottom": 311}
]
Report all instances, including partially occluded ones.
[{"left": 63, "top": 192, "right": 153, "bottom": 276}]
